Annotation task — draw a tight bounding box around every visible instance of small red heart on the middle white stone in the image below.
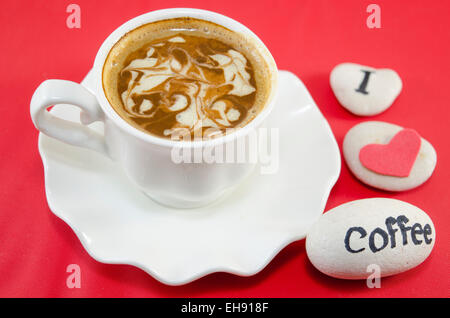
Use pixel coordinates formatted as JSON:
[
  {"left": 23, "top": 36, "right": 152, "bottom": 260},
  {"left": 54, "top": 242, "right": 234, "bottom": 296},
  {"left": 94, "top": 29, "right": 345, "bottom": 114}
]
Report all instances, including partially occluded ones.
[{"left": 359, "top": 129, "right": 422, "bottom": 177}]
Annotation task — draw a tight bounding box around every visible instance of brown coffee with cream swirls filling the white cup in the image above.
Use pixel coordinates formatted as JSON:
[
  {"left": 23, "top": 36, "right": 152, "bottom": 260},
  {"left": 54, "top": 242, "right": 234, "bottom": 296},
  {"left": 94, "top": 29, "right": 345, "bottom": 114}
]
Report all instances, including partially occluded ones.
[{"left": 102, "top": 18, "right": 271, "bottom": 138}]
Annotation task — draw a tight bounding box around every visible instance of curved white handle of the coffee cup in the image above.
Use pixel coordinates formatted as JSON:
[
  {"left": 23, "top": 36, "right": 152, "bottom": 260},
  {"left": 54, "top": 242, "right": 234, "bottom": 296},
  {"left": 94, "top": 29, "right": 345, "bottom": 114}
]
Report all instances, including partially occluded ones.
[{"left": 30, "top": 80, "right": 108, "bottom": 155}]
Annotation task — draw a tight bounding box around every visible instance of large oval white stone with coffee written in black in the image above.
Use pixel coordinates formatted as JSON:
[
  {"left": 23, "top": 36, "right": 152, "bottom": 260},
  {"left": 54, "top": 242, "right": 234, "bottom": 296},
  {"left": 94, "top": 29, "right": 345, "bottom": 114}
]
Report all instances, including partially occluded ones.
[{"left": 306, "top": 198, "right": 436, "bottom": 279}]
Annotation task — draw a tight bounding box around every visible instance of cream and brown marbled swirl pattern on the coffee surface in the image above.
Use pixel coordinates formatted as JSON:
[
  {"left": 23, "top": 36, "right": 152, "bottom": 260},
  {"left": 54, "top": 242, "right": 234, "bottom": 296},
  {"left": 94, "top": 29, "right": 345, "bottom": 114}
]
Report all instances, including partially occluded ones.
[{"left": 120, "top": 34, "right": 256, "bottom": 136}]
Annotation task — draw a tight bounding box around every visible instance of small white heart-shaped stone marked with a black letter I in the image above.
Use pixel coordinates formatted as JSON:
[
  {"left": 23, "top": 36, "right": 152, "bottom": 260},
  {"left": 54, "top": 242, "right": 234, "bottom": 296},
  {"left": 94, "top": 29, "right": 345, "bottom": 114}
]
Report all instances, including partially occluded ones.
[{"left": 330, "top": 63, "right": 402, "bottom": 116}]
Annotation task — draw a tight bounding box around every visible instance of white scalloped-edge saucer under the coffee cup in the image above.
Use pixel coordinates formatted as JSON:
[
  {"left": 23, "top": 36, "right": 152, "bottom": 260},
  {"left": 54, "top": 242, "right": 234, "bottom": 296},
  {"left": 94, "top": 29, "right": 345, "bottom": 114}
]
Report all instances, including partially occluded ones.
[{"left": 39, "top": 71, "right": 341, "bottom": 285}]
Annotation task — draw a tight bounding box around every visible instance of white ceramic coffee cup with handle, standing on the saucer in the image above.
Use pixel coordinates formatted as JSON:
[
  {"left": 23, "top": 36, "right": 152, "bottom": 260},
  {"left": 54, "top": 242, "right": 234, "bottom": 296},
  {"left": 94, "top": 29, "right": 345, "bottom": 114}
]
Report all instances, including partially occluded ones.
[{"left": 30, "top": 8, "right": 278, "bottom": 208}]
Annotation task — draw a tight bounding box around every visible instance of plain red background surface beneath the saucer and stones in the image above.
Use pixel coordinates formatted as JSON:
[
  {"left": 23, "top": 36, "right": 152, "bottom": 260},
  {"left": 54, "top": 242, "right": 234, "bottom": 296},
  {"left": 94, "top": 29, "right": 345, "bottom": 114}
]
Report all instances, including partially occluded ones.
[{"left": 0, "top": 0, "right": 450, "bottom": 297}]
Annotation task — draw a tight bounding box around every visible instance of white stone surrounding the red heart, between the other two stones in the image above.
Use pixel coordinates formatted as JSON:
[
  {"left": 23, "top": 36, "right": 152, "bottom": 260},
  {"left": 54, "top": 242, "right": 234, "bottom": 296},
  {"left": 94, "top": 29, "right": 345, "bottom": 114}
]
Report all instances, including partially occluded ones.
[{"left": 343, "top": 121, "right": 437, "bottom": 191}]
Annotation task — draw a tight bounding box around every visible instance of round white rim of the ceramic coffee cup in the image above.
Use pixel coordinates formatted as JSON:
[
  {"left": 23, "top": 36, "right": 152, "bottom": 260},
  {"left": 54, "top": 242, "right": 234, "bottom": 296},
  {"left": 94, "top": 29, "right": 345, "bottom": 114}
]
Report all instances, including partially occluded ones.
[{"left": 94, "top": 8, "right": 278, "bottom": 148}]
